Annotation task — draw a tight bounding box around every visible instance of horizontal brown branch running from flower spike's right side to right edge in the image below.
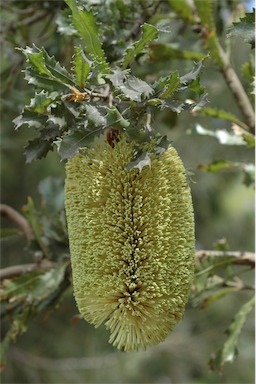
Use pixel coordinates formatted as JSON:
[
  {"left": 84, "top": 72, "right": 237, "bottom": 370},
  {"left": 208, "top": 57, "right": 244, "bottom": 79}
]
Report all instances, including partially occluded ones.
[{"left": 196, "top": 250, "right": 255, "bottom": 268}]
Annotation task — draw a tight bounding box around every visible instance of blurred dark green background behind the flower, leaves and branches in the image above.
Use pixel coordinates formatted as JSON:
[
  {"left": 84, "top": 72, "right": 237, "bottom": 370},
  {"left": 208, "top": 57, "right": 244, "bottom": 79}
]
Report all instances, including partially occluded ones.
[{"left": 1, "top": 0, "right": 254, "bottom": 384}]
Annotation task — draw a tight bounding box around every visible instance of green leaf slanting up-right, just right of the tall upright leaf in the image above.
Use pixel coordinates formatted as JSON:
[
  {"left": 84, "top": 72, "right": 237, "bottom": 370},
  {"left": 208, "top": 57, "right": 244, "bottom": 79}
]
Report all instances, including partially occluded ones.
[{"left": 122, "top": 23, "right": 158, "bottom": 69}]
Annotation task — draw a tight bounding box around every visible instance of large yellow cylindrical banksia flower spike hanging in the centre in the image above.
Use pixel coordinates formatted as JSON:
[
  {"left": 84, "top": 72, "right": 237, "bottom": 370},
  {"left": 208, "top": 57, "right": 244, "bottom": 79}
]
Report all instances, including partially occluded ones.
[{"left": 65, "top": 136, "right": 194, "bottom": 351}]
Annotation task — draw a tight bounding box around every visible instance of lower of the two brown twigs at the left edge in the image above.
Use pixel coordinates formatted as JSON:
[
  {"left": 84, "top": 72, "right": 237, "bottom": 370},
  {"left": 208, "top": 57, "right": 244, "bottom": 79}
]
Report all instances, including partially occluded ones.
[{"left": 0, "top": 259, "right": 56, "bottom": 280}]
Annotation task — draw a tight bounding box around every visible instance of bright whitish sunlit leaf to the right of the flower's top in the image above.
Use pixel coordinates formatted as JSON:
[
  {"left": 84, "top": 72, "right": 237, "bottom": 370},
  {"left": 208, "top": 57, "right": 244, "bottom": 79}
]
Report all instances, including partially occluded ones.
[{"left": 190, "top": 124, "right": 246, "bottom": 145}]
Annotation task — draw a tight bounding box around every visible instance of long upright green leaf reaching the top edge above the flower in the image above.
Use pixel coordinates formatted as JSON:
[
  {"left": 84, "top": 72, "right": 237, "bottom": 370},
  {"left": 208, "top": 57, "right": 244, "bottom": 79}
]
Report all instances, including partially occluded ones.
[{"left": 65, "top": 0, "right": 108, "bottom": 71}]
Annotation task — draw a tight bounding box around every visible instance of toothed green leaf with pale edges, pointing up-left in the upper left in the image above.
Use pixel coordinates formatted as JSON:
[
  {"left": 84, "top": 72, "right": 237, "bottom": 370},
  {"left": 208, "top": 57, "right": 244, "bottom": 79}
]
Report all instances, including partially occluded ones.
[{"left": 21, "top": 45, "right": 75, "bottom": 86}]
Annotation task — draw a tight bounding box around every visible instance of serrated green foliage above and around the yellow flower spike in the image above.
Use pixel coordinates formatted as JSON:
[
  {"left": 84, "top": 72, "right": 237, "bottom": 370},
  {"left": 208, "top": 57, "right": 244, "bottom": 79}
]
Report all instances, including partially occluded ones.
[{"left": 1, "top": 0, "right": 255, "bottom": 378}]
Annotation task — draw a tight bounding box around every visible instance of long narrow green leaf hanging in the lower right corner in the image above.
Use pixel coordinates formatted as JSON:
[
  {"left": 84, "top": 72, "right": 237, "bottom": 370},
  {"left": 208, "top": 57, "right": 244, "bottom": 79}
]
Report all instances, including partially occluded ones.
[{"left": 209, "top": 296, "right": 255, "bottom": 371}]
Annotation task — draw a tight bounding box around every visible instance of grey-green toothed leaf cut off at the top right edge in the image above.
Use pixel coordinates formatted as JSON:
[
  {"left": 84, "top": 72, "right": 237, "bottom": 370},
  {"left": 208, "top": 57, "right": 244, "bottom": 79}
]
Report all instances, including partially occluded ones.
[{"left": 227, "top": 9, "right": 255, "bottom": 49}]
